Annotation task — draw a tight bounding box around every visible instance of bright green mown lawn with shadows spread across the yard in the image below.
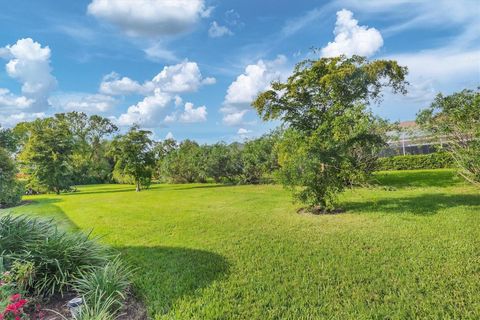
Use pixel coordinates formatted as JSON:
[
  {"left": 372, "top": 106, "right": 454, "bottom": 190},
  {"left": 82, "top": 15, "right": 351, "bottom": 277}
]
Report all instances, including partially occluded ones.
[{"left": 1, "top": 170, "right": 480, "bottom": 319}]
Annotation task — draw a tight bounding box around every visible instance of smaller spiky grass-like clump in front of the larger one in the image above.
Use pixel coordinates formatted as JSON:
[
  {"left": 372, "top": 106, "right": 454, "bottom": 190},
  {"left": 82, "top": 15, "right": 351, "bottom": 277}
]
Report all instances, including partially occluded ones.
[{"left": 73, "top": 256, "right": 132, "bottom": 312}]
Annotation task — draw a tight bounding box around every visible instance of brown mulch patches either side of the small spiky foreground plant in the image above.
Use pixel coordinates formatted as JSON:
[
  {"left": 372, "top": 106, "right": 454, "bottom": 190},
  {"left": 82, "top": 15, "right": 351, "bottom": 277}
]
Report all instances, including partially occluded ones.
[{"left": 42, "top": 293, "right": 148, "bottom": 320}]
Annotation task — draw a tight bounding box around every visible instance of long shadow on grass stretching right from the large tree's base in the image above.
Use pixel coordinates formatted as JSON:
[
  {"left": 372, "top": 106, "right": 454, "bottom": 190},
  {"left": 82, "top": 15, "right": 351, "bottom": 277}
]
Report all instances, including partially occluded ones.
[{"left": 342, "top": 193, "right": 480, "bottom": 215}]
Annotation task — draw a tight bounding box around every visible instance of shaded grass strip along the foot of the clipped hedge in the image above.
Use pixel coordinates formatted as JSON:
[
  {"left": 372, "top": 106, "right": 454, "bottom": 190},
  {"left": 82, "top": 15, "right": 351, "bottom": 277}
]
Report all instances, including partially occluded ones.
[{"left": 373, "top": 170, "right": 463, "bottom": 188}]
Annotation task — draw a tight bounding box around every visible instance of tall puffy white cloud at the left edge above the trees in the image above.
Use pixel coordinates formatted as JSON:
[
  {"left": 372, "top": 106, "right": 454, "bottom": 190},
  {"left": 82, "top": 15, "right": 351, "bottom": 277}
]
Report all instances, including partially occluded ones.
[{"left": 0, "top": 38, "right": 57, "bottom": 110}]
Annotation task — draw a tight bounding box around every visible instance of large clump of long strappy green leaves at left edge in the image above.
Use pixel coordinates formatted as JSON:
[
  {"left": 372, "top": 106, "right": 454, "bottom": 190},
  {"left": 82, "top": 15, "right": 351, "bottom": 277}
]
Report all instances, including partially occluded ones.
[{"left": 0, "top": 215, "right": 110, "bottom": 295}]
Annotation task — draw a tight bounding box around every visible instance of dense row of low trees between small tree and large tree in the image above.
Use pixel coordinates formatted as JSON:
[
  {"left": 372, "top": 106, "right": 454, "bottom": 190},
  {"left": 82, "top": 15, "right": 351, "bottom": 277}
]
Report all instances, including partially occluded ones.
[{"left": 155, "top": 132, "right": 280, "bottom": 184}]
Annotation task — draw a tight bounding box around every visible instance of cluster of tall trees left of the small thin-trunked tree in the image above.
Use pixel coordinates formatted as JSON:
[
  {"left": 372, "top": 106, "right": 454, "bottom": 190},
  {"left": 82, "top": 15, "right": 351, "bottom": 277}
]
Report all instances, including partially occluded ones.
[{"left": 13, "top": 112, "right": 118, "bottom": 193}]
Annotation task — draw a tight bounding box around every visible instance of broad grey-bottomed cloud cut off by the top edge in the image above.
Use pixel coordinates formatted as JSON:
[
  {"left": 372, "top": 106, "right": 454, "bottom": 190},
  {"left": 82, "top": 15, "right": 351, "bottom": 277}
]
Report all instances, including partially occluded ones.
[{"left": 87, "top": 0, "right": 212, "bottom": 37}]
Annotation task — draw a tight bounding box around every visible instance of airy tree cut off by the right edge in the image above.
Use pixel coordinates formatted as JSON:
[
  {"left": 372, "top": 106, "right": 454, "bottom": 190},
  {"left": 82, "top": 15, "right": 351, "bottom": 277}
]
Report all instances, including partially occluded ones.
[{"left": 417, "top": 89, "right": 480, "bottom": 184}]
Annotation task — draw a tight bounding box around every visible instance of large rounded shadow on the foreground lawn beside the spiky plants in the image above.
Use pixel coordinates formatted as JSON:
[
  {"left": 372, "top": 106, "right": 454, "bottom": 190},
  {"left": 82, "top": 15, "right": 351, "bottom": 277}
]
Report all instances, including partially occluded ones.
[{"left": 116, "top": 247, "right": 229, "bottom": 315}]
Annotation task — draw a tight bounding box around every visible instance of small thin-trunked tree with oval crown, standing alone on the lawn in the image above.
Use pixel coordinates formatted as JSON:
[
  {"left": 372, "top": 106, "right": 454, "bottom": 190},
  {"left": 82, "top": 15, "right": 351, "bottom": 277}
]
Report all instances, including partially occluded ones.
[{"left": 110, "top": 126, "right": 155, "bottom": 192}]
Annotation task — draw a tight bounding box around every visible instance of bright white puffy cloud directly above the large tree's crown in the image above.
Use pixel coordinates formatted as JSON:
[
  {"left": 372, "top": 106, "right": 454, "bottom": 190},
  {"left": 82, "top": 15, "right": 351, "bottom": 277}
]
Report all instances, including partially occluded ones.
[{"left": 322, "top": 9, "right": 383, "bottom": 57}]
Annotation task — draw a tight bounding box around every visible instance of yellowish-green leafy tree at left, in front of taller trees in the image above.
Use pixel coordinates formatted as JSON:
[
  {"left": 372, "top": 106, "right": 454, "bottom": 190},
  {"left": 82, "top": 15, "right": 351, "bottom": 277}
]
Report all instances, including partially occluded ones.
[{"left": 20, "top": 118, "right": 74, "bottom": 194}]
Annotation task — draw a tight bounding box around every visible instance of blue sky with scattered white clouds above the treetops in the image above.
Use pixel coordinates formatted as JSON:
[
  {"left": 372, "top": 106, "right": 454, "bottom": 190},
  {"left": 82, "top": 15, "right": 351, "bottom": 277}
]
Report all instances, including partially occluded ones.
[{"left": 0, "top": 0, "right": 480, "bottom": 142}]
